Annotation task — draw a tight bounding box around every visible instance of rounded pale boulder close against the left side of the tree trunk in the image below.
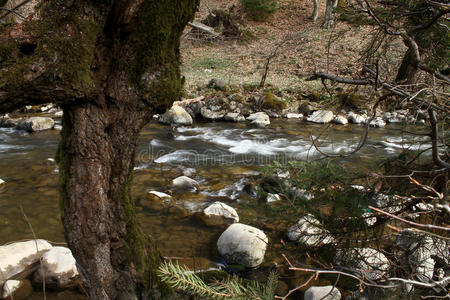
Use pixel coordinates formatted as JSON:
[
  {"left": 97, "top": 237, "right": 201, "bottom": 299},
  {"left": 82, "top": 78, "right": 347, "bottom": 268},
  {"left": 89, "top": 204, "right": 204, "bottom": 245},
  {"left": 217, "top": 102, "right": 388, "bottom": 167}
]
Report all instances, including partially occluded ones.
[{"left": 34, "top": 247, "right": 78, "bottom": 287}]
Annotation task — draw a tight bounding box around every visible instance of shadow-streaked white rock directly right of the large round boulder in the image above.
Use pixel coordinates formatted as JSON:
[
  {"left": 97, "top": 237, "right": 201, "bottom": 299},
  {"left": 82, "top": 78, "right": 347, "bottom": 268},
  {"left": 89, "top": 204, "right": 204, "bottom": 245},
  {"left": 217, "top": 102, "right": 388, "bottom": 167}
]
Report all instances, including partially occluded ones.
[{"left": 287, "top": 214, "right": 336, "bottom": 247}]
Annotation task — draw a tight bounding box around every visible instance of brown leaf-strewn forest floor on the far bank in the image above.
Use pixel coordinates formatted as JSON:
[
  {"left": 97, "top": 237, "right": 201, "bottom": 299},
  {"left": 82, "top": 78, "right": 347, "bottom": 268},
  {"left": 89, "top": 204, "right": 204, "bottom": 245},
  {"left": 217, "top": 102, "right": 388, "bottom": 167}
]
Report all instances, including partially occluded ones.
[{"left": 182, "top": 0, "right": 404, "bottom": 93}]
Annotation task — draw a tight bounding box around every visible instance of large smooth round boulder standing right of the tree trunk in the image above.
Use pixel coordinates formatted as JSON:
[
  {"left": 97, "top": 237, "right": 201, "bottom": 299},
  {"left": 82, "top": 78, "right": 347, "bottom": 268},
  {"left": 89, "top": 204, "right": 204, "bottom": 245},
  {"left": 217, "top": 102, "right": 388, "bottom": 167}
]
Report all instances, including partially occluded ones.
[{"left": 217, "top": 223, "right": 268, "bottom": 268}]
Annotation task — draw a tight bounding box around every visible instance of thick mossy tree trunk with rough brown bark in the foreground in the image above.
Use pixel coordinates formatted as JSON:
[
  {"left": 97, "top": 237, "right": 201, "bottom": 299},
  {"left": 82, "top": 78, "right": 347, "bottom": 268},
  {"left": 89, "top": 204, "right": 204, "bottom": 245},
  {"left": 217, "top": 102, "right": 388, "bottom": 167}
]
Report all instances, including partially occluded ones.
[{"left": 0, "top": 0, "right": 198, "bottom": 299}]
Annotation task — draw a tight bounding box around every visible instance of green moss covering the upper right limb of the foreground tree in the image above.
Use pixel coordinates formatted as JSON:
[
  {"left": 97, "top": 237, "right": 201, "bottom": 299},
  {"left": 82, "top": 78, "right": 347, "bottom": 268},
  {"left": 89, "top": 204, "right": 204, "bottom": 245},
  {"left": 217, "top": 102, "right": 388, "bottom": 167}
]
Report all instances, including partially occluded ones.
[{"left": 129, "top": 0, "right": 199, "bottom": 110}]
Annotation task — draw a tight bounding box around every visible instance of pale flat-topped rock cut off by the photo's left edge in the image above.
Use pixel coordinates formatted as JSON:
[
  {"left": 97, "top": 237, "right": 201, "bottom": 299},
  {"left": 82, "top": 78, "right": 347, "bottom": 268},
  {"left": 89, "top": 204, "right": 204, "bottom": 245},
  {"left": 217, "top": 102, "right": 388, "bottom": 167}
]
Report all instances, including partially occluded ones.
[{"left": 0, "top": 240, "right": 52, "bottom": 286}]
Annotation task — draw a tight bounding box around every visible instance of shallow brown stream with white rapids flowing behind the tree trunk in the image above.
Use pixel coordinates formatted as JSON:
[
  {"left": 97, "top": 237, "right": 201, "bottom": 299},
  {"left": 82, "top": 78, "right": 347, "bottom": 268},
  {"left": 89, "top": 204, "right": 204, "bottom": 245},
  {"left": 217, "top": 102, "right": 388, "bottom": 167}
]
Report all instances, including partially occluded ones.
[{"left": 0, "top": 120, "right": 427, "bottom": 299}]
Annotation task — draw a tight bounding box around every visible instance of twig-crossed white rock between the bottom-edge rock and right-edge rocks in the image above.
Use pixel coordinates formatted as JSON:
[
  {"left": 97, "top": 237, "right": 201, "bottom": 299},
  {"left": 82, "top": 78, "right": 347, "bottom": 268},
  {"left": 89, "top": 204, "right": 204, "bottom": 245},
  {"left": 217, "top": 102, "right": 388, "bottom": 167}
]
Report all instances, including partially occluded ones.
[{"left": 335, "top": 248, "right": 390, "bottom": 280}]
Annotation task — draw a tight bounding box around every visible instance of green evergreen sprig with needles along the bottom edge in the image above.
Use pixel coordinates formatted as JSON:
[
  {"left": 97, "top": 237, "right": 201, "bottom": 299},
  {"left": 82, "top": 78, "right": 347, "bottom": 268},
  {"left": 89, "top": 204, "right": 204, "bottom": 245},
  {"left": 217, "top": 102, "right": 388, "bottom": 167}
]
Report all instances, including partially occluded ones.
[{"left": 158, "top": 261, "right": 278, "bottom": 300}]
